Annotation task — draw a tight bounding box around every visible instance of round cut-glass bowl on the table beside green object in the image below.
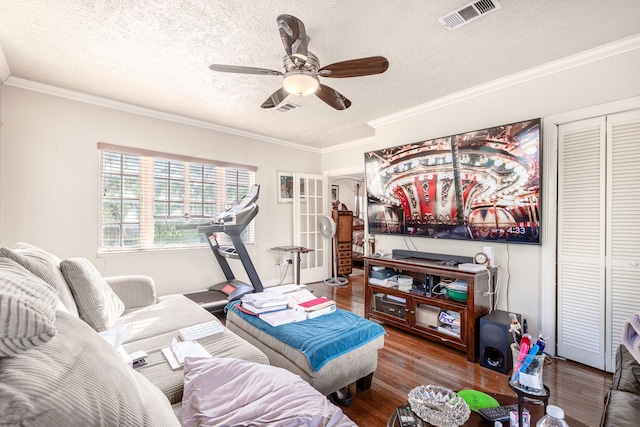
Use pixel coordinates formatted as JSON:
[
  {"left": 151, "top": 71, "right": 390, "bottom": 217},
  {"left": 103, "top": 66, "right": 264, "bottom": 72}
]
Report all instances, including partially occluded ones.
[{"left": 408, "top": 385, "right": 471, "bottom": 427}]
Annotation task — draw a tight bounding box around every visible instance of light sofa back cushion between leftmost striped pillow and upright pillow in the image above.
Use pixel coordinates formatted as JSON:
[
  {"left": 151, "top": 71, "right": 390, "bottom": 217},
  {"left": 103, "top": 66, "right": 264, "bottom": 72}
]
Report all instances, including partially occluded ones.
[{"left": 0, "top": 243, "right": 78, "bottom": 316}]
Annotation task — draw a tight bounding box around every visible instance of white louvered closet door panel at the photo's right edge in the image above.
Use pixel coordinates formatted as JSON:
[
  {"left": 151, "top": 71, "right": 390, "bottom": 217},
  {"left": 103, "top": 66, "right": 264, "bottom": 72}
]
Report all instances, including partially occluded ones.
[{"left": 606, "top": 111, "right": 640, "bottom": 371}]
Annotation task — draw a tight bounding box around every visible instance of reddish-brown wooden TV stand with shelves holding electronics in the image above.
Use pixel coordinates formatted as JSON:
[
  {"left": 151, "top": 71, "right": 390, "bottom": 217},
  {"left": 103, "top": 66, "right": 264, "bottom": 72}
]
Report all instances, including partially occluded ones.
[{"left": 364, "top": 257, "right": 496, "bottom": 362}]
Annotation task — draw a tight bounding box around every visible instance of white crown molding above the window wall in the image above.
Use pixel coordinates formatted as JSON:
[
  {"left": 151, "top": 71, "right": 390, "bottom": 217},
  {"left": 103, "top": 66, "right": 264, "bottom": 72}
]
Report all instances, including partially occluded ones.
[{"left": 0, "top": 77, "right": 320, "bottom": 153}]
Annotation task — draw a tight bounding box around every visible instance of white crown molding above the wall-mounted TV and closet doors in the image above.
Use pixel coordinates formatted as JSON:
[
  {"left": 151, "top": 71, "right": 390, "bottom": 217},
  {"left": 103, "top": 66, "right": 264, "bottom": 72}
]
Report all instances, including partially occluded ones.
[{"left": 367, "top": 33, "right": 640, "bottom": 129}]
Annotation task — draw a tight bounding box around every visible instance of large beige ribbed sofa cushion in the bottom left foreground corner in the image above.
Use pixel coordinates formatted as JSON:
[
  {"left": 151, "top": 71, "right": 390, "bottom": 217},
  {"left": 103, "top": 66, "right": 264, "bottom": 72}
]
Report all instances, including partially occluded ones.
[{"left": 0, "top": 311, "right": 180, "bottom": 427}]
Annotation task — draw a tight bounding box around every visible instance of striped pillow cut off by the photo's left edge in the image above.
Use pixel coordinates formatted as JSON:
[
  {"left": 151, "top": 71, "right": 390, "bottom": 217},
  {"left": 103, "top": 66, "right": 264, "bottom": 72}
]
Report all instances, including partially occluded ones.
[{"left": 0, "top": 257, "right": 59, "bottom": 358}]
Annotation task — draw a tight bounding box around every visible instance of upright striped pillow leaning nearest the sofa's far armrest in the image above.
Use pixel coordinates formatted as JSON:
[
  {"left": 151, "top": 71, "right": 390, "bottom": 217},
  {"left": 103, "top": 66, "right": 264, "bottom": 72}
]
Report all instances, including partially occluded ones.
[{"left": 60, "top": 258, "right": 124, "bottom": 332}]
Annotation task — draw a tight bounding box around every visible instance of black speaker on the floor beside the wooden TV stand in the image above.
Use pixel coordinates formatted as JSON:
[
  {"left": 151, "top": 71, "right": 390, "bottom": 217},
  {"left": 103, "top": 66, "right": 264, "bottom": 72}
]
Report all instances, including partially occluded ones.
[{"left": 480, "top": 310, "right": 521, "bottom": 374}]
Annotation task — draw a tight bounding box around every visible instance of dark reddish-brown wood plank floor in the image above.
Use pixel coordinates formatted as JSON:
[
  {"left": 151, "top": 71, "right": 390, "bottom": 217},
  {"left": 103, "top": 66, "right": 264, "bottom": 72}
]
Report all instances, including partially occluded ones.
[{"left": 308, "top": 275, "right": 612, "bottom": 426}]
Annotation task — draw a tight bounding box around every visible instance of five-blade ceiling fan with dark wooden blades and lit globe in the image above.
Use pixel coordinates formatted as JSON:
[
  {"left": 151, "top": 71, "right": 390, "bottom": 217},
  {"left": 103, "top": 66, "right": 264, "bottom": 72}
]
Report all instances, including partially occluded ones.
[{"left": 209, "top": 15, "right": 389, "bottom": 110}]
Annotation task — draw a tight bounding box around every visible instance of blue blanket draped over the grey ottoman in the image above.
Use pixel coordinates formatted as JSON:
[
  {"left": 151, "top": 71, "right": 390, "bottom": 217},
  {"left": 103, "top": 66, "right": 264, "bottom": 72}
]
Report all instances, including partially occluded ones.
[{"left": 227, "top": 303, "right": 385, "bottom": 372}]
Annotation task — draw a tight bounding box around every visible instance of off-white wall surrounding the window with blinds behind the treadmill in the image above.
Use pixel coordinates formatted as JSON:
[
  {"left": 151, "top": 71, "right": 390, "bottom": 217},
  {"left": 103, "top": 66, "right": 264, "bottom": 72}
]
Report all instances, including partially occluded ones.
[{"left": 0, "top": 84, "right": 320, "bottom": 295}]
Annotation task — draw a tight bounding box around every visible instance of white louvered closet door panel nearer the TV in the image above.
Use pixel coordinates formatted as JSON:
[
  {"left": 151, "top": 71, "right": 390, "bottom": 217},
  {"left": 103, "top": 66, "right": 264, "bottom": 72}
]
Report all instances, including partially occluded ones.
[{"left": 557, "top": 118, "right": 604, "bottom": 369}]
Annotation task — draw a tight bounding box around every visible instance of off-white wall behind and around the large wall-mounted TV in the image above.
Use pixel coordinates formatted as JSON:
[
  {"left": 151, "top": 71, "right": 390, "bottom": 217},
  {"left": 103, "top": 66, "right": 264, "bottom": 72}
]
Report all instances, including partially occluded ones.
[{"left": 322, "top": 43, "right": 640, "bottom": 335}]
